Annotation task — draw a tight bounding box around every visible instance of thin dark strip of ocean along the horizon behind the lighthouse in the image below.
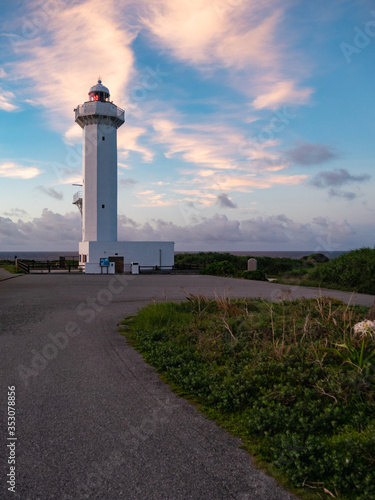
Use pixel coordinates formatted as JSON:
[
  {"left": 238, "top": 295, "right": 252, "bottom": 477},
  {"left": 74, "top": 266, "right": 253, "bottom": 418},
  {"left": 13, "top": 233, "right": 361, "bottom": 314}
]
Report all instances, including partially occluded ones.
[{"left": 0, "top": 250, "right": 345, "bottom": 262}]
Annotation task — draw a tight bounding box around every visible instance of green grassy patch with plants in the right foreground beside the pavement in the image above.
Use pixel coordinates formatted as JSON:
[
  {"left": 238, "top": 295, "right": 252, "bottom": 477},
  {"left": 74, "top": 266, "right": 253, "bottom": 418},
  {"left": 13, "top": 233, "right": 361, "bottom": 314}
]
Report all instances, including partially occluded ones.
[{"left": 123, "top": 296, "right": 375, "bottom": 500}]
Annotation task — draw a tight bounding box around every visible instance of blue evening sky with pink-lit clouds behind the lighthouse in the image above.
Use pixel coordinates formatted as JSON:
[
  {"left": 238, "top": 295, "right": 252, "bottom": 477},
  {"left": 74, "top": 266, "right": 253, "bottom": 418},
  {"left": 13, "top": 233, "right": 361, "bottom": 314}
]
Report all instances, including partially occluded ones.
[{"left": 0, "top": 0, "right": 375, "bottom": 252}]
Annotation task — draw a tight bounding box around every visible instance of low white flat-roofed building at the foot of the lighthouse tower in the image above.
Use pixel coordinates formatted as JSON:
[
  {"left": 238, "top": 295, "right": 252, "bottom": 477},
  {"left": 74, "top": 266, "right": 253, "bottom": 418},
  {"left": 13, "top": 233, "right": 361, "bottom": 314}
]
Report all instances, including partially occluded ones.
[{"left": 79, "top": 241, "right": 174, "bottom": 274}]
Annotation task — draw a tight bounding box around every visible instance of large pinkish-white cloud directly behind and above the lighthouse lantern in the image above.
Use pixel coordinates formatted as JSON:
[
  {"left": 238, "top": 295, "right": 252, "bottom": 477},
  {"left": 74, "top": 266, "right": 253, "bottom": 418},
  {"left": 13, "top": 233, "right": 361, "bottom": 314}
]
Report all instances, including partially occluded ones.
[{"left": 9, "top": 0, "right": 135, "bottom": 128}]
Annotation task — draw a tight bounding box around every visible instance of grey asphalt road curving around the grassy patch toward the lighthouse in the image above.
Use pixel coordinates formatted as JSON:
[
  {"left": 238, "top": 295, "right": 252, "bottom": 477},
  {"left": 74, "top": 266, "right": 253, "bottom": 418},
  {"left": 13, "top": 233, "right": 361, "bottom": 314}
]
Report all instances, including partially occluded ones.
[{"left": 0, "top": 273, "right": 374, "bottom": 500}]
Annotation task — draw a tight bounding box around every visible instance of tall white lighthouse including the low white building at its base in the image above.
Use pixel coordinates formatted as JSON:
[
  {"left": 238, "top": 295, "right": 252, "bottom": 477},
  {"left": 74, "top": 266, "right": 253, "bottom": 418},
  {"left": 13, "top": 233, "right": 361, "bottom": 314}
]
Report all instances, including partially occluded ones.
[{"left": 73, "top": 78, "right": 174, "bottom": 274}]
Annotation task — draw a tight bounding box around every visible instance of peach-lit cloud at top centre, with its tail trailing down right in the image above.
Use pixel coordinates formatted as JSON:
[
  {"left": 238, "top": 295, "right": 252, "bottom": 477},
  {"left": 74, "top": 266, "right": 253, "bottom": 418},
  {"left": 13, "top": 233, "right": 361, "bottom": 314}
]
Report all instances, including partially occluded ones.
[{"left": 142, "top": 0, "right": 313, "bottom": 109}]
